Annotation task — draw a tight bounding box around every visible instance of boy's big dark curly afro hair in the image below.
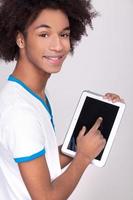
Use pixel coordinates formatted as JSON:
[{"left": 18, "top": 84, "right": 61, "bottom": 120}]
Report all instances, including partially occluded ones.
[{"left": 0, "top": 0, "right": 97, "bottom": 62}]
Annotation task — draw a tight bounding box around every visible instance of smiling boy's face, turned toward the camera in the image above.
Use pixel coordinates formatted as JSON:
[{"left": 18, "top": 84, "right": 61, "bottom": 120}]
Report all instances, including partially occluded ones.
[{"left": 20, "top": 9, "right": 70, "bottom": 74}]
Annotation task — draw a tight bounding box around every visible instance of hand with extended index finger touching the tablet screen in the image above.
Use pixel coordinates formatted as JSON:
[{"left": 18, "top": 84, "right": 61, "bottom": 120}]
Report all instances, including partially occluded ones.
[{"left": 77, "top": 117, "right": 106, "bottom": 162}]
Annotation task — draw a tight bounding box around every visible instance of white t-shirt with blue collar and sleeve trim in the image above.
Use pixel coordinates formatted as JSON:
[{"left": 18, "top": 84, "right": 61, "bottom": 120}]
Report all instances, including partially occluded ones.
[{"left": 0, "top": 76, "right": 61, "bottom": 200}]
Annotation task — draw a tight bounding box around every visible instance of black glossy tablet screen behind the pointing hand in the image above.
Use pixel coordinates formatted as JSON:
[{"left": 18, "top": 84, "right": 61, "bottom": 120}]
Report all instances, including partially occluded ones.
[{"left": 68, "top": 97, "right": 119, "bottom": 160}]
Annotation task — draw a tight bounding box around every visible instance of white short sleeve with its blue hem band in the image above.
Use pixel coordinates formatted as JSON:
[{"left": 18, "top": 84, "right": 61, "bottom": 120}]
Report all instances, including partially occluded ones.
[{"left": 5, "top": 104, "right": 45, "bottom": 163}]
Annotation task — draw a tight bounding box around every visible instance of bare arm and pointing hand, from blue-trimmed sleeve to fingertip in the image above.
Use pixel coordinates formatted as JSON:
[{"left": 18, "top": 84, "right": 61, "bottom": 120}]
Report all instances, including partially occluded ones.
[{"left": 18, "top": 119, "right": 105, "bottom": 200}]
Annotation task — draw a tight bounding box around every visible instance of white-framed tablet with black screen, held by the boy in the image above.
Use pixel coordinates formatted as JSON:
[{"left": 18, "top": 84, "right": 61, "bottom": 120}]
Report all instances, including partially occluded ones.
[{"left": 61, "top": 91, "right": 125, "bottom": 167}]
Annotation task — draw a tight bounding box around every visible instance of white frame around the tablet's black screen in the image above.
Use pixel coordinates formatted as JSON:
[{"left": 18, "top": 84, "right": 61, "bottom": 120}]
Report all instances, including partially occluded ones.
[{"left": 61, "top": 91, "right": 125, "bottom": 167}]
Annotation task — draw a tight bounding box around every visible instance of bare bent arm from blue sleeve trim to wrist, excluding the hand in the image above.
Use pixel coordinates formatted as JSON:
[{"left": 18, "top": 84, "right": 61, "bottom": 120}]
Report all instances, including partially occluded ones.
[{"left": 19, "top": 150, "right": 90, "bottom": 200}]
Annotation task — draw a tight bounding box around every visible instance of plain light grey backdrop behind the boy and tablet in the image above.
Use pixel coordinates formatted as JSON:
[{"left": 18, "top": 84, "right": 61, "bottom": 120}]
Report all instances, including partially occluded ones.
[{"left": 0, "top": 0, "right": 133, "bottom": 200}]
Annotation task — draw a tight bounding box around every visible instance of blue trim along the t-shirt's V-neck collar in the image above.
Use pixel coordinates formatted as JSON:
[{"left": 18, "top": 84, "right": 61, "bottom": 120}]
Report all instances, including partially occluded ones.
[{"left": 8, "top": 75, "right": 55, "bottom": 128}]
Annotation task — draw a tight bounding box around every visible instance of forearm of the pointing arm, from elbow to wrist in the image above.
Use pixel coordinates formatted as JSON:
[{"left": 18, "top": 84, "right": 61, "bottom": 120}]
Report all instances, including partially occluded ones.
[{"left": 51, "top": 155, "right": 90, "bottom": 200}]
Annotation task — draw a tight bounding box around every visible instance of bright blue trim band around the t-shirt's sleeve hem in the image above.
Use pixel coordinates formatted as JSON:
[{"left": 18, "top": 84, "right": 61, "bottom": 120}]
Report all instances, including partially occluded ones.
[{"left": 14, "top": 149, "right": 46, "bottom": 163}]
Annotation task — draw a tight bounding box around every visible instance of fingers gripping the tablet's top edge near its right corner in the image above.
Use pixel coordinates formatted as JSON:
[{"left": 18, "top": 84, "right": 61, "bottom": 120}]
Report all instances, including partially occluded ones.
[{"left": 103, "top": 93, "right": 124, "bottom": 103}]
